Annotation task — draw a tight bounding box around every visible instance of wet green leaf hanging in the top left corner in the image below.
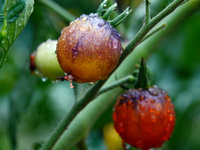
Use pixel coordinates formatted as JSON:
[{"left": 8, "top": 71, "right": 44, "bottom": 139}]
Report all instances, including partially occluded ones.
[{"left": 0, "top": 0, "right": 34, "bottom": 68}]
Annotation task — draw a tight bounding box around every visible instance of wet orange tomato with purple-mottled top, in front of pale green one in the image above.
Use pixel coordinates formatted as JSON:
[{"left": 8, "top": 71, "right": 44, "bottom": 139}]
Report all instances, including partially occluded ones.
[{"left": 57, "top": 14, "right": 122, "bottom": 83}]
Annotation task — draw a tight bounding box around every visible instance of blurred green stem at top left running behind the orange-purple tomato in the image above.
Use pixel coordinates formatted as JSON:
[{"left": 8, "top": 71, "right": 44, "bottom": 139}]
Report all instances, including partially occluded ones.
[{"left": 36, "top": 0, "right": 76, "bottom": 23}]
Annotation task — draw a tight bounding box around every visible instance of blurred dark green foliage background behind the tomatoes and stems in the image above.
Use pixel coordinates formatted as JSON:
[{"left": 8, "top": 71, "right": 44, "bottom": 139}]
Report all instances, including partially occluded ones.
[{"left": 0, "top": 0, "right": 200, "bottom": 150}]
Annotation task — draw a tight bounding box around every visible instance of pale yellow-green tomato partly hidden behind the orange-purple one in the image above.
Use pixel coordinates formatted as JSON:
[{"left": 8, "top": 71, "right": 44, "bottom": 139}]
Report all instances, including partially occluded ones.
[{"left": 34, "top": 39, "right": 64, "bottom": 80}]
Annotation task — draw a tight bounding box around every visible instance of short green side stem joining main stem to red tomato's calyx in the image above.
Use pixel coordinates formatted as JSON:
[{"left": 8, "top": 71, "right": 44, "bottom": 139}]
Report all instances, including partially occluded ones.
[{"left": 98, "top": 75, "right": 136, "bottom": 95}]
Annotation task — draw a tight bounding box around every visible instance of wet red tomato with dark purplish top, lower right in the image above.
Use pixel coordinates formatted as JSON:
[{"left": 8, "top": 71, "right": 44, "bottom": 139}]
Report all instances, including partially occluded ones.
[{"left": 113, "top": 87, "right": 175, "bottom": 150}]
